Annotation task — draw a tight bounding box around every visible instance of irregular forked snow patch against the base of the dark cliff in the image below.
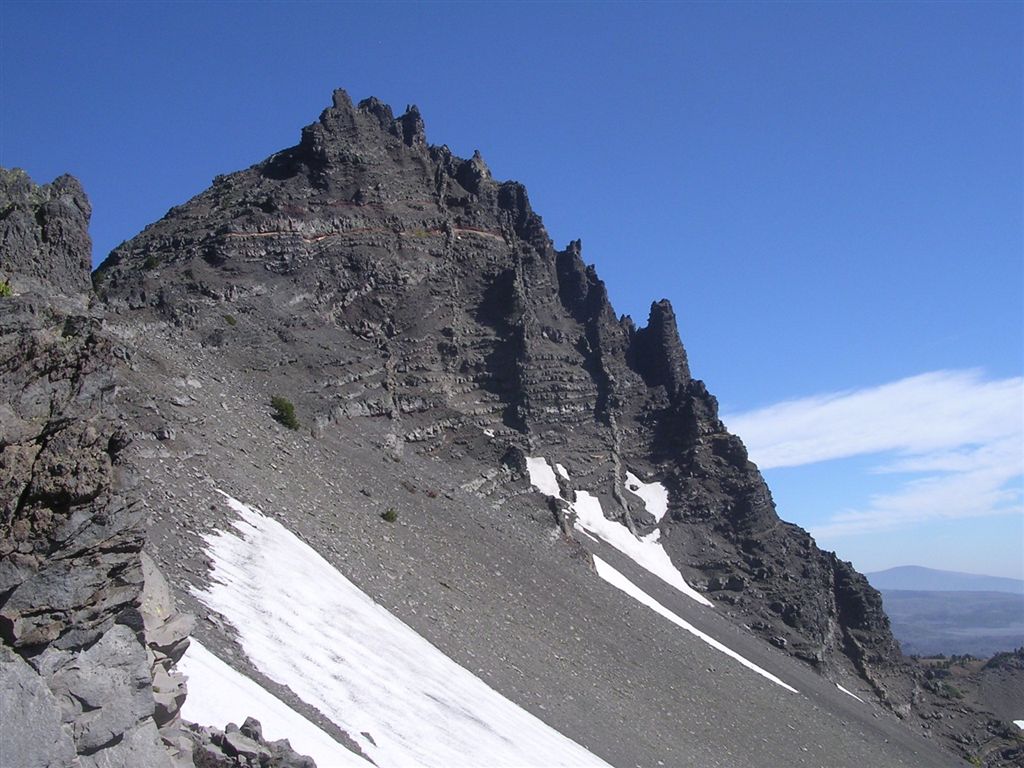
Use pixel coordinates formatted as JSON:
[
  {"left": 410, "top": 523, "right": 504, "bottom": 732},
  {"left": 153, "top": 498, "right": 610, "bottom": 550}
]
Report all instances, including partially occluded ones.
[{"left": 526, "top": 457, "right": 715, "bottom": 608}]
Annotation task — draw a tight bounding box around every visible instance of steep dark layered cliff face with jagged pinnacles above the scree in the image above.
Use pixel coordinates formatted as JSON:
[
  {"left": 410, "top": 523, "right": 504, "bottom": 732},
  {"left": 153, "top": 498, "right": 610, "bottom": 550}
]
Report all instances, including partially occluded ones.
[{"left": 90, "top": 91, "right": 905, "bottom": 684}]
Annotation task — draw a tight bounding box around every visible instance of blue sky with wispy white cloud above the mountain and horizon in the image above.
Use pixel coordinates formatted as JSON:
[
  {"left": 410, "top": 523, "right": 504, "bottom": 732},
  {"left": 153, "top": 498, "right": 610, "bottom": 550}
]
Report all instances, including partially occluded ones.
[{"left": 0, "top": 0, "right": 1024, "bottom": 578}]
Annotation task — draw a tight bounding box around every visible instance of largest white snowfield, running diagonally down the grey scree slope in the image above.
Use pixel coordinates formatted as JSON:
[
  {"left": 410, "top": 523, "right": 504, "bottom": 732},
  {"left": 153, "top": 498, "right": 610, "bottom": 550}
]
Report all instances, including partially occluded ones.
[{"left": 195, "top": 493, "right": 607, "bottom": 768}]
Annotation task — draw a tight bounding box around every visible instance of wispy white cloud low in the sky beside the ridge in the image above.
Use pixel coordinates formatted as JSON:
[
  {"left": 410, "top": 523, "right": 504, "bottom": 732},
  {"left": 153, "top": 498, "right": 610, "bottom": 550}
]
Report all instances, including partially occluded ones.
[{"left": 725, "top": 371, "right": 1024, "bottom": 540}]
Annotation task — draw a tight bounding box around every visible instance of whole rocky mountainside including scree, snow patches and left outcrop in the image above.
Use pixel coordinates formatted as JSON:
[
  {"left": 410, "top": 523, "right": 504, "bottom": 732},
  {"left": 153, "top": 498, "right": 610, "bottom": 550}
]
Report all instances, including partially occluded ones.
[{"left": 0, "top": 91, "right": 1024, "bottom": 768}]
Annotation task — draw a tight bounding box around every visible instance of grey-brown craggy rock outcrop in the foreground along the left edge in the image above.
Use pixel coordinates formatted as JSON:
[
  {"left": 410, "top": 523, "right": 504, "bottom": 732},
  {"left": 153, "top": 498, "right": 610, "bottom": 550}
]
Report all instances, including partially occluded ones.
[{"left": 0, "top": 171, "right": 188, "bottom": 767}]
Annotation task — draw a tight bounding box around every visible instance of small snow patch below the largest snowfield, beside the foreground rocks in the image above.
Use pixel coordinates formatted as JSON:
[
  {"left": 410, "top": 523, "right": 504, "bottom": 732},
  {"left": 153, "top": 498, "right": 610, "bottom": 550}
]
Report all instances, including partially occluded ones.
[{"left": 177, "top": 638, "right": 371, "bottom": 768}]
